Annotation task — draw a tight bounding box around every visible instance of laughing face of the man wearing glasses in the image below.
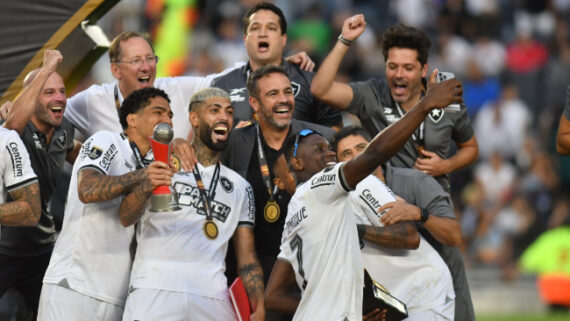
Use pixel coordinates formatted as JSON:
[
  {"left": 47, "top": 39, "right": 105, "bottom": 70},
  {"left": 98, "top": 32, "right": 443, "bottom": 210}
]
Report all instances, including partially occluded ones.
[{"left": 111, "top": 37, "right": 156, "bottom": 97}]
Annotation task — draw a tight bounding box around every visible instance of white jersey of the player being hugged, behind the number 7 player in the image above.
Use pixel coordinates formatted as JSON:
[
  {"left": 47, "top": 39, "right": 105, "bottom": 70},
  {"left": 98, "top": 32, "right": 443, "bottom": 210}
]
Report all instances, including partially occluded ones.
[{"left": 350, "top": 175, "right": 455, "bottom": 317}]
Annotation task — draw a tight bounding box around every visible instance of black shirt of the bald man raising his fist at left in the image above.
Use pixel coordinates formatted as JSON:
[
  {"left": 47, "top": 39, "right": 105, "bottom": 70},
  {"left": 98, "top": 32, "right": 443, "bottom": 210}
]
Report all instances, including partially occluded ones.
[{"left": 0, "top": 118, "right": 74, "bottom": 256}]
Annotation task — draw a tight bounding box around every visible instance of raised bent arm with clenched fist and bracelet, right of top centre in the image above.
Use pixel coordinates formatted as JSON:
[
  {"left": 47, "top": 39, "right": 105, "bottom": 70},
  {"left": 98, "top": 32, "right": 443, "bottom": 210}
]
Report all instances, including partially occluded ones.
[{"left": 311, "top": 14, "right": 366, "bottom": 109}]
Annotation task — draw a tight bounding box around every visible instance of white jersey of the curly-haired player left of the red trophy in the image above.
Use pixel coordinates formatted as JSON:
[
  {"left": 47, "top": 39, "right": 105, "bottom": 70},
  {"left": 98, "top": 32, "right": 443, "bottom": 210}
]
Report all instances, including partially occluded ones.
[{"left": 44, "top": 131, "right": 136, "bottom": 305}]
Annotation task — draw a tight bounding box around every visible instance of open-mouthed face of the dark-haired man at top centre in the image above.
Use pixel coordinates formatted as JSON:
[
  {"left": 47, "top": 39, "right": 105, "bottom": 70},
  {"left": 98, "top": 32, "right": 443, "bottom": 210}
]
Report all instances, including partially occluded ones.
[{"left": 243, "top": 10, "right": 287, "bottom": 70}]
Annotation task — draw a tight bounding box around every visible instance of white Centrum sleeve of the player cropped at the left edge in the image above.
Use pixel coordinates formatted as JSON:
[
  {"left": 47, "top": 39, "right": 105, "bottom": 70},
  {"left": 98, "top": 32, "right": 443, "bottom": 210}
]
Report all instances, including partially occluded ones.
[{"left": 0, "top": 126, "right": 37, "bottom": 204}]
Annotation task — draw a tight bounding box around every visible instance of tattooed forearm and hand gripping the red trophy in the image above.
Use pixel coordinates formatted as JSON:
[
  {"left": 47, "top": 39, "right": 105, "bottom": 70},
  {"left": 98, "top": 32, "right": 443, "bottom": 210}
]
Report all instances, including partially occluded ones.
[{"left": 119, "top": 161, "right": 173, "bottom": 226}]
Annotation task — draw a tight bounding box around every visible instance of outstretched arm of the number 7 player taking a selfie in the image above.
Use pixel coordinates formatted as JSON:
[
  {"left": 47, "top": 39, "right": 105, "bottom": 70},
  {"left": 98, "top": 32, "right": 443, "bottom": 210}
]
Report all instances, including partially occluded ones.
[{"left": 342, "top": 72, "right": 463, "bottom": 188}]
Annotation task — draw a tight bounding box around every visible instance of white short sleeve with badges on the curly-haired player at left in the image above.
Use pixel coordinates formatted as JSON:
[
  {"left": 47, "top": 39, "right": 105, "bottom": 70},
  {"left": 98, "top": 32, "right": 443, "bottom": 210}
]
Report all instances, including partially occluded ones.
[{"left": 76, "top": 131, "right": 120, "bottom": 174}]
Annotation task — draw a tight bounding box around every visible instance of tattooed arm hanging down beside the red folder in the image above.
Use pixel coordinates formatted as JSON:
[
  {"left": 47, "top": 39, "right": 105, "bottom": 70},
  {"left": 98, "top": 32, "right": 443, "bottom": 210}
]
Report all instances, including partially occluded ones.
[{"left": 233, "top": 226, "right": 265, "bottom": 320}]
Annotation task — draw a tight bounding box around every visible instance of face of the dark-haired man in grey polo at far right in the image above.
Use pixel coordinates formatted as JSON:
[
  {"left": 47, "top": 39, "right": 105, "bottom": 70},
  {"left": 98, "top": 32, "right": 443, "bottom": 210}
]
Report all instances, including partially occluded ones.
[{"left": 386, "top": 47, "right": 428, "bottom": 110}]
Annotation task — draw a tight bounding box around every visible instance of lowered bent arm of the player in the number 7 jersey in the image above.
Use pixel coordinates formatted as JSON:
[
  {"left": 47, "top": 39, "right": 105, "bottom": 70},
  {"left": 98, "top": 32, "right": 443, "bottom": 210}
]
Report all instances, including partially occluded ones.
[{"left": 265, "top": 258, "right": 301, "bottom": 314}]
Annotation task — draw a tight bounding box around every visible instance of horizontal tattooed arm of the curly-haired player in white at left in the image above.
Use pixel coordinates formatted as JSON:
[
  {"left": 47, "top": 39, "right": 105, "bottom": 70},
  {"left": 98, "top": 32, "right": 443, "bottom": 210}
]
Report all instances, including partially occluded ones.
[{"left": 78, "top": 169, "right": 146, "bottom": 203}]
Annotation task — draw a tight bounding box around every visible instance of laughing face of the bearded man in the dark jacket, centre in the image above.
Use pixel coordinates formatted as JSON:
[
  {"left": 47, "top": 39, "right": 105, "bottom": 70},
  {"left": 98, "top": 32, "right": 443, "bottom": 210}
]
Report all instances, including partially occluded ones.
[{"left": 249, "top": 72, "right": 295, "bottom": 129}]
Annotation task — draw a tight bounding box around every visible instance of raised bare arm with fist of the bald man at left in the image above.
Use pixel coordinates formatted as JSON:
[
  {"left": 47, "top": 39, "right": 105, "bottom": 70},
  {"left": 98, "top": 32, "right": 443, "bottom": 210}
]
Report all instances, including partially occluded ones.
[{"left": 4, "top": 50, "right": 63, "bottom": 135}]
